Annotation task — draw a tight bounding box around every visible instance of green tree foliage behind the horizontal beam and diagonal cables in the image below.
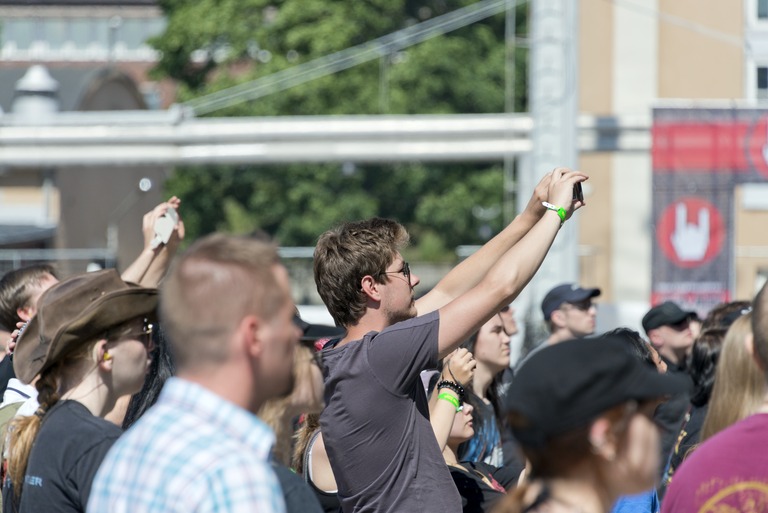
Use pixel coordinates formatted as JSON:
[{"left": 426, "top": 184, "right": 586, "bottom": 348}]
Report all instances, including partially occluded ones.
[{"left": 152, "top": 0, "right": 526, "bottom": 258}]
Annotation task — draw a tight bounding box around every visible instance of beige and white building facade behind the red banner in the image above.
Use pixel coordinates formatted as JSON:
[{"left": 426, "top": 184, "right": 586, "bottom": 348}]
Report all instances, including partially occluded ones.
[{"left": 578, "top": 0, "right": 768, "bottom": 328}]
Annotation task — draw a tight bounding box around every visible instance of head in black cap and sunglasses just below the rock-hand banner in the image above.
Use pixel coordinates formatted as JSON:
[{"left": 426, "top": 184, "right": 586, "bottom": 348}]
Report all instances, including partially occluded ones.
[{"left": 643, "top": 301, "right": 696, "bottom": 370}]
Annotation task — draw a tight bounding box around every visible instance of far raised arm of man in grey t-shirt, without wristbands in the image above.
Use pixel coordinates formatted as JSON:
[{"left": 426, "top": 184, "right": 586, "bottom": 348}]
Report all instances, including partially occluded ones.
[{"left": 416, "top": 173, "right": 552, "bottom": 315}]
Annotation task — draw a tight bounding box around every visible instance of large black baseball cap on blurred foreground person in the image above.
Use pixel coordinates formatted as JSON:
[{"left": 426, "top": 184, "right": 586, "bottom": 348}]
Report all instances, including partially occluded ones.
[{"left": 505, "top": 336, "right": 688, "bottom": 447}]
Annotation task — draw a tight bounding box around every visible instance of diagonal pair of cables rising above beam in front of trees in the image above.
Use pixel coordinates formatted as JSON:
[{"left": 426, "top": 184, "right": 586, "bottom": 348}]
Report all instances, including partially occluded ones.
[{"left": 184, "top": 0, "right": 523, "bottom": 115}]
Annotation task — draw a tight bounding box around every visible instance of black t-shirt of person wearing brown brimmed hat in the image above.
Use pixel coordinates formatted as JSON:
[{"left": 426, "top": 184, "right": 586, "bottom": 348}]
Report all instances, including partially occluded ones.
[{"left": 3, "top": 401, "right": 122, "bottom": 513}]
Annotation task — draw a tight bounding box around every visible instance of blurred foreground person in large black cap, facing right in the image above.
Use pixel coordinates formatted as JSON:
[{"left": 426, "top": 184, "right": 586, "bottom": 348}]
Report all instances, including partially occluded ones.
[{"left": 497, "top": 338, "right": 686, "bottom": 513}]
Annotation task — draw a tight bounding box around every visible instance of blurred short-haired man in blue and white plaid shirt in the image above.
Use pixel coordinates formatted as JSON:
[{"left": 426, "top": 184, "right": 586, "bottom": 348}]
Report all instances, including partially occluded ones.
[{"left": 88, "top": 235, "right": 300, "bottom": 513}]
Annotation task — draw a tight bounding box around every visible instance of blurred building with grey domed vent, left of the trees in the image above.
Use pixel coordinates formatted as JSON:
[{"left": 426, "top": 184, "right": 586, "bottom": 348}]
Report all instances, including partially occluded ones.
[{"left": 0, "top": 0, "right": 174, "bottom": 274}]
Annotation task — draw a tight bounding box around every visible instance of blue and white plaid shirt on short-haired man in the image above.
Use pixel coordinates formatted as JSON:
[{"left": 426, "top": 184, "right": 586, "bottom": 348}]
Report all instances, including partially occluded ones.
[{"left": 87, "top": 378, "right": 285, "bottom": 513}]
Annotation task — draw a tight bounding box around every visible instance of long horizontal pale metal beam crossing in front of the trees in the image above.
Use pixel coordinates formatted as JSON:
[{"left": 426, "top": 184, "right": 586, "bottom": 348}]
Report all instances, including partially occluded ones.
[{"left": 0, "top": 112, "right": 650, "bottom": 167}]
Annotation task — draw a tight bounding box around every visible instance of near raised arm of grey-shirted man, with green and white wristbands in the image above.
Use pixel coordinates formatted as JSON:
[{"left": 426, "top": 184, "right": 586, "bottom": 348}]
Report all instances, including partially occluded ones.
[{"left": 438, "top": 168, "right": 587, "bottom": 356}]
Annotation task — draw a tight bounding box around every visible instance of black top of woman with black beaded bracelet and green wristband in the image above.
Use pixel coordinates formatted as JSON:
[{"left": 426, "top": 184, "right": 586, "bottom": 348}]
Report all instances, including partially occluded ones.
[{"left": 449, "top": 461, "right": 513, "bottom": 513}]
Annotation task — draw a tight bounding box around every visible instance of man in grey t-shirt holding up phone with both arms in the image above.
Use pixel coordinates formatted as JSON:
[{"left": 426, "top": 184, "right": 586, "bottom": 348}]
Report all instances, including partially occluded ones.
[{"left": 314, "top": 168, "right": 587, "bottom": 513}]
